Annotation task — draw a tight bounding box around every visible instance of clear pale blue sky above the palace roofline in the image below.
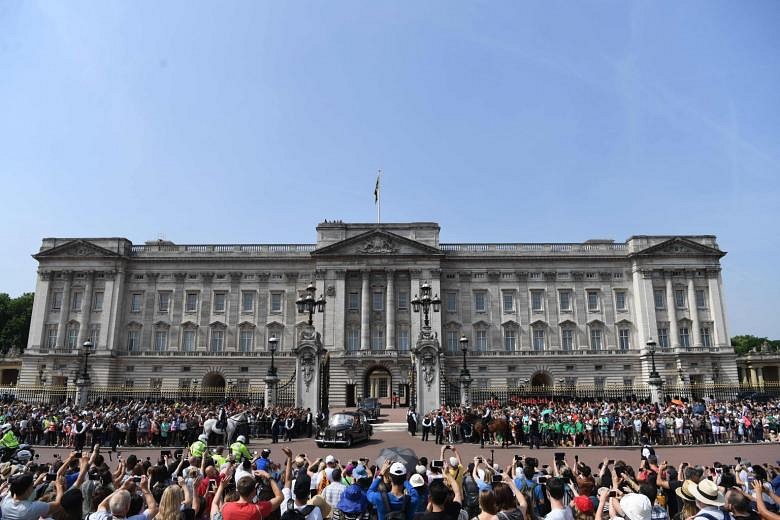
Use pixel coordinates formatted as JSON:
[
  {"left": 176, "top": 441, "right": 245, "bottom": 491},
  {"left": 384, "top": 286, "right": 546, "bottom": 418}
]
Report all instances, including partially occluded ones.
[{"left": 0, "top": 0, "right": 780, "bottom": 338}]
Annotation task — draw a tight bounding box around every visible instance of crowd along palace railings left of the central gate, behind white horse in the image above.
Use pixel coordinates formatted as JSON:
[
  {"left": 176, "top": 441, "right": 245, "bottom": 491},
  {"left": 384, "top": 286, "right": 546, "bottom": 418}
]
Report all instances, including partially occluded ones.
[{"left": 0, "top": 400, "right": 322, "bottom": 448}]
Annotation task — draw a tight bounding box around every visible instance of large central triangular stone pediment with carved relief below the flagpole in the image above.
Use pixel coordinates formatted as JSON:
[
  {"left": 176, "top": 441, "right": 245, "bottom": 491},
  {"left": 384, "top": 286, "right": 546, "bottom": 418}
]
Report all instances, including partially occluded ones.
[{"left": 312, "top": 229, "right": 444, "bottom": 256}]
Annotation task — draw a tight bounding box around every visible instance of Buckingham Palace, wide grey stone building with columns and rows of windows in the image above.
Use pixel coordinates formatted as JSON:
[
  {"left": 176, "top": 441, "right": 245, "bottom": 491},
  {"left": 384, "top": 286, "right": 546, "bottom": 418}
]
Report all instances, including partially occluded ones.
[{"left": 19, "top": 221, "right": 738, "bottom": 406}]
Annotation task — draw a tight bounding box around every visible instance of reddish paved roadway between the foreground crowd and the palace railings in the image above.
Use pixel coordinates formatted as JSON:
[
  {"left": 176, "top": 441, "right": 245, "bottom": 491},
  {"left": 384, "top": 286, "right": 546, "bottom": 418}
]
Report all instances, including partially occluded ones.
[{"left": 25, "top": 409, "right": 780, "bottom": 469}]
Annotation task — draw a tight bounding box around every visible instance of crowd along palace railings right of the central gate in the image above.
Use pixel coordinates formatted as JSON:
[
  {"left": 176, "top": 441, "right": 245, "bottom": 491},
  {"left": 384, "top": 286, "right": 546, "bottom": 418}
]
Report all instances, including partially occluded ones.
[{"left": 407, "top": 398, "right": 780, "bottom": 447}]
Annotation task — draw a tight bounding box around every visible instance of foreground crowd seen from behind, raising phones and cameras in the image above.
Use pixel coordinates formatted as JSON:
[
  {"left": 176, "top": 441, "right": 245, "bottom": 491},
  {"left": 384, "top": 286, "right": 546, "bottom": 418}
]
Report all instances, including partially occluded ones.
[{"left": 0, "top": 438, "right": 780, "bottom": 520}]
